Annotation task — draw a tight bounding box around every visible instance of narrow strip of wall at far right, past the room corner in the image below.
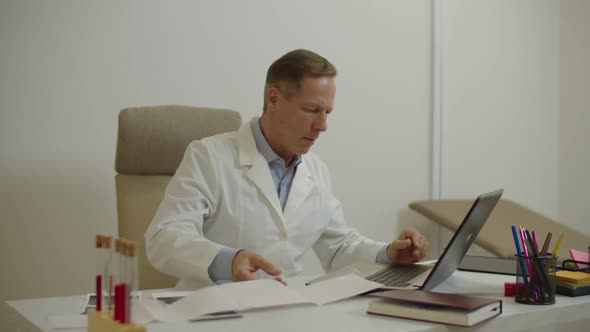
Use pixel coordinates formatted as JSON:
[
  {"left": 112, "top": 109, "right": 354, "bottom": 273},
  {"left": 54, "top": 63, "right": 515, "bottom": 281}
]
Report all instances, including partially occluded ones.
[{"left": 558, "top": 0, "right": 590, "bottom": 237}]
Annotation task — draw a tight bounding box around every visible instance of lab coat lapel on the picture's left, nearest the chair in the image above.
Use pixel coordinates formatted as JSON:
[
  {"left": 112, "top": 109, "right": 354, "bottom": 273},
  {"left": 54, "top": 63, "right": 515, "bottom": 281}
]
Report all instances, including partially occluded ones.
[{"left": 238, "top": 122, "right": 287, "bottom": 238}]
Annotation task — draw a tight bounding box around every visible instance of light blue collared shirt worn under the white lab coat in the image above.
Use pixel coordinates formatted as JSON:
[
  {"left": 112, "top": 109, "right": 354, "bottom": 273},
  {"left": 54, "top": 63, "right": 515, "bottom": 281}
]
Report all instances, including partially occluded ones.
[{"left": 208, "top": 118, "right": 392, "bottom": 283}]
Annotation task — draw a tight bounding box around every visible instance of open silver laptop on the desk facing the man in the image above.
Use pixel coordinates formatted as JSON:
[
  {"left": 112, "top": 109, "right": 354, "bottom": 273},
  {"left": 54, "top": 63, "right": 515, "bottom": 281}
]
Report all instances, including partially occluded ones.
[{"left": 307, "top": 189, "right": 504, "bottom": 290}]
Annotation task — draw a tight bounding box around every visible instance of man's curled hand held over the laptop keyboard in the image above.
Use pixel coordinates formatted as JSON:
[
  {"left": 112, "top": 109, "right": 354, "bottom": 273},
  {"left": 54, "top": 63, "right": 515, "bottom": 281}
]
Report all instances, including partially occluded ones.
[{"left": 387, "top": 227, "right": 430, "bottom": 264}]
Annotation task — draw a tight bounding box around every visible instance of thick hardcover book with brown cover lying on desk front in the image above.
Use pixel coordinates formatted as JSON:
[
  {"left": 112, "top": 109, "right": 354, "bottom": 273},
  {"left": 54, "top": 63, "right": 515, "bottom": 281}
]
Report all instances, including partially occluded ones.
[{"left": 367, "top": 290, "right": 502, "bottom": 326}]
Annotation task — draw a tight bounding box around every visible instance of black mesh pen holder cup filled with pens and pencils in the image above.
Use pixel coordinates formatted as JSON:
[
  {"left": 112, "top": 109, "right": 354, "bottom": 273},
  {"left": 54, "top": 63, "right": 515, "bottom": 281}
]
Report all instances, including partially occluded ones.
[{"left": 515, "top": 255, "right": 557, "bottom": 304}]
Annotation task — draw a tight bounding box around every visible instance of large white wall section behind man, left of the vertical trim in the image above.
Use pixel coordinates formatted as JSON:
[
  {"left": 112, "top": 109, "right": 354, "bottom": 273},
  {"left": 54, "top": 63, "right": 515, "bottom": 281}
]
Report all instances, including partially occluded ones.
[{"left": 0, "top": 0, "right": 430, "bottom": 299}]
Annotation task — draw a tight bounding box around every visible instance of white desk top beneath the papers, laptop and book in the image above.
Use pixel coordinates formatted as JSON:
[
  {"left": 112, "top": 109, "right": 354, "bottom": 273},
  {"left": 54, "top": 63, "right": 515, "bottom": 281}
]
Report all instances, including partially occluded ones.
[{"left": 7, "top": 271, "right": 590, "bottom": 332}]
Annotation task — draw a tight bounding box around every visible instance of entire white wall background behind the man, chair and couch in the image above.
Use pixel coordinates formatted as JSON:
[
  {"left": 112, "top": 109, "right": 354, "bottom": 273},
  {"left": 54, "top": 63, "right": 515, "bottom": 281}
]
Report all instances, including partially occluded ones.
[{"left": 0, "top": 0, "right": 590, "bottom": 300}]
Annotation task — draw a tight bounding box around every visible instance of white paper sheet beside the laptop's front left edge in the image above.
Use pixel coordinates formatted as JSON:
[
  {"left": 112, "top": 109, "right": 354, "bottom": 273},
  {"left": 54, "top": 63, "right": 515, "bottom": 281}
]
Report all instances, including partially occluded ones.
[{"left": 296, "top": 274, "right": 381, "bottom": 305}]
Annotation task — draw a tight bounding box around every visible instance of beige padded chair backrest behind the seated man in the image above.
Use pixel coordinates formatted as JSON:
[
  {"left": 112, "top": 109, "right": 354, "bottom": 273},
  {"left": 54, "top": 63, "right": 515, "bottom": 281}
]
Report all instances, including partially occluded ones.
[{"left": 115, "top": 106, "right": 242, "bottom": 289}]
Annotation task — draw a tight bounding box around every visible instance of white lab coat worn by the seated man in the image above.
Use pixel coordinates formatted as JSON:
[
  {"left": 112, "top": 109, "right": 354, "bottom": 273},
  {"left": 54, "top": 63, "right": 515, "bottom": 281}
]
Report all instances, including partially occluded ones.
[{"left": 145, "top": 119, "right": 386, "bottom": 287}]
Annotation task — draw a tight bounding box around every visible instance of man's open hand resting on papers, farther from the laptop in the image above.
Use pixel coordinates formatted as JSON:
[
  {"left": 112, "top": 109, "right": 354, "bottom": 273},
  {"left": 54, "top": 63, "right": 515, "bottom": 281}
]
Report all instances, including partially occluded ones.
[{"left": 232, "top": 250, "right": 286, "bottom": 285}]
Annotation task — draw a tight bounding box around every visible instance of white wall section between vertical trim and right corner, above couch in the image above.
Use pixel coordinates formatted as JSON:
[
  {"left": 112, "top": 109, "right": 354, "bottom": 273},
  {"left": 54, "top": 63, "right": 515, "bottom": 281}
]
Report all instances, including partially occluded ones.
[{"left": 446, "top": 0, "right": 559, "bottom": 218}]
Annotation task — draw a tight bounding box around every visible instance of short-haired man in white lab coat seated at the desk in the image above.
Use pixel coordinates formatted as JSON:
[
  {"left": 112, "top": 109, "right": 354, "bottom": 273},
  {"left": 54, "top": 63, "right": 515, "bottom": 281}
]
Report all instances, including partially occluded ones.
[{"left": 145, "top": 50, "right": 429, "bottom": 287}]
